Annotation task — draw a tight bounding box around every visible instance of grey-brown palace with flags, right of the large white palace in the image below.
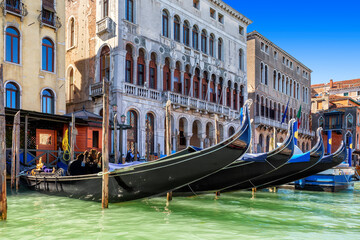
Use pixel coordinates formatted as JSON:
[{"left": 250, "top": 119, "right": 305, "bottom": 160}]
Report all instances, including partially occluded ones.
[{"left": 247, "top": 31, "right": 314, "bottom": 152}]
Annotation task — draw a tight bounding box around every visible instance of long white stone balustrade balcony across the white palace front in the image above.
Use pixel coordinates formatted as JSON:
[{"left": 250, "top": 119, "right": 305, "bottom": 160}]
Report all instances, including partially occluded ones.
[{"left": 124, "top": 83, "right": 240, "bottom": 119}]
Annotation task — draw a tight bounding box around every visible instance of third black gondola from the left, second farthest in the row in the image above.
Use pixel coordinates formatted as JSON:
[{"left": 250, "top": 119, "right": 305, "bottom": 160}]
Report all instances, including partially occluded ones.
[{"left": 249, "top": 128, "right": 324, "bottom": 188}]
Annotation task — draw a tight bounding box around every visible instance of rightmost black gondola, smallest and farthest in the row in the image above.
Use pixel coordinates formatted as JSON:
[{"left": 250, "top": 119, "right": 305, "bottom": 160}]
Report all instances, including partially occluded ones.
[{"left": 294, "top": 141, "right": 347, "bottom": 189}]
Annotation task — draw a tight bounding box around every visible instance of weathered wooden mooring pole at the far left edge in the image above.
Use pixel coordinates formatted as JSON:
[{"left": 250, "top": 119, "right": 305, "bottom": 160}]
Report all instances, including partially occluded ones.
[{"left": 0, "top": 64, "right": 7, "bottom": 220}]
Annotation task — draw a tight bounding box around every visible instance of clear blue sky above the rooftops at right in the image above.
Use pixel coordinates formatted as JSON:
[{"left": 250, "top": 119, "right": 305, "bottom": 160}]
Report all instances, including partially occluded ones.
[{"left": 224, "top": 0, "right": 360, "bottom": 84}]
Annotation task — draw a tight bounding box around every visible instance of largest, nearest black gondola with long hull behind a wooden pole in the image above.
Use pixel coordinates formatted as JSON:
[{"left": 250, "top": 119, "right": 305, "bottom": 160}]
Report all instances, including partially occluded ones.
[{"left": 21, "top": 100, "right": 251, "bottom": 202}]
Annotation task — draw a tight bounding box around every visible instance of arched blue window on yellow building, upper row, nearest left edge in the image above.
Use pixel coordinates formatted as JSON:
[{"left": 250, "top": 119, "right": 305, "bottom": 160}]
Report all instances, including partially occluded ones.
[{"left": 5, "top": 27, "right": 20, "bottom": 63}]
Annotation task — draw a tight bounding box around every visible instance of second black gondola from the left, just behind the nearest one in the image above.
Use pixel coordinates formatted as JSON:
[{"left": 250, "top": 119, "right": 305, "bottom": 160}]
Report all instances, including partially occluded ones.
[{"left": 176, "top": 120, "right": 295, "bottom": 195}]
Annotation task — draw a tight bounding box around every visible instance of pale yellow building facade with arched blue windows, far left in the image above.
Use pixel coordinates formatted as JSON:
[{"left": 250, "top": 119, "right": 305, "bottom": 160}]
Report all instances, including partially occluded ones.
[{"left": 0, "top": 0, "right": 66, "bottom": 114}]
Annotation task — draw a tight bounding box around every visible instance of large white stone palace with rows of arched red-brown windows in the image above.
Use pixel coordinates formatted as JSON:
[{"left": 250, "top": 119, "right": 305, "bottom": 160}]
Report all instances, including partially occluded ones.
[{"left": 67, "top": 0, "right": 251, "bottom": 159}]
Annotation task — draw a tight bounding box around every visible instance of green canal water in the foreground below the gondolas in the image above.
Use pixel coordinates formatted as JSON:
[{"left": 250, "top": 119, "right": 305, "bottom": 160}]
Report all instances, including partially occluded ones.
[{"left": 0, "top": 184, "right": 360, "bottom": 240}]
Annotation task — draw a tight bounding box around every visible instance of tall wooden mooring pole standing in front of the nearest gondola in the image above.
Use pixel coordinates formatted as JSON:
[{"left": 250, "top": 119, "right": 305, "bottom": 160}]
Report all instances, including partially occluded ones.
[{"left": 101, "top": 78, "right": 110, "bottom": 208}]
